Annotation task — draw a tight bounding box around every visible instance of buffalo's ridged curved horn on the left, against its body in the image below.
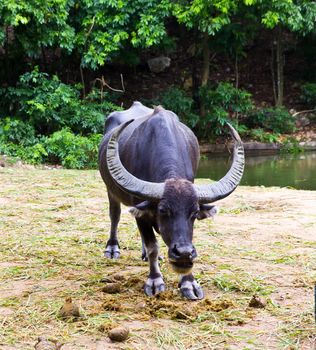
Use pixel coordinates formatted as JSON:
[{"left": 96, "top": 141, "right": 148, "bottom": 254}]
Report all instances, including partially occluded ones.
[{"left": 106, "top": 120, "right": 165, "bottom": 201}]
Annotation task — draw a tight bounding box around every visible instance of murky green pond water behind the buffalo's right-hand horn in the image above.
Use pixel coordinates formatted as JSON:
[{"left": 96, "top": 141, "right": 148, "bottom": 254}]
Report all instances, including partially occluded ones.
[{"left": 197, "top": 152, "right": 316, "bottom": 190}]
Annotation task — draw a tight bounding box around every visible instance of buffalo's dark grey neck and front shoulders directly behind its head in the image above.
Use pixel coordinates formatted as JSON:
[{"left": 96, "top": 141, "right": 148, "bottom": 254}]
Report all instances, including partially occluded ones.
[{"left": 120, "top": 115, "right": 198, "bottom": 182}]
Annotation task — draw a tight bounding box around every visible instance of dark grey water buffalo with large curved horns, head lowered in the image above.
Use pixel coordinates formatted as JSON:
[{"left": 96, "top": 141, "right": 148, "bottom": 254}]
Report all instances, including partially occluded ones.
[{"left": 99, "top": 102, "right": 244, "bottom": 300}]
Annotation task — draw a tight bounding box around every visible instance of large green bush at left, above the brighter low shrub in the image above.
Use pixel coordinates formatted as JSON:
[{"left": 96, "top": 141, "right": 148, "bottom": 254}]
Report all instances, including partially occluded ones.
[{"left": 0, "top": 68, "right": 116, "bottom": 135}]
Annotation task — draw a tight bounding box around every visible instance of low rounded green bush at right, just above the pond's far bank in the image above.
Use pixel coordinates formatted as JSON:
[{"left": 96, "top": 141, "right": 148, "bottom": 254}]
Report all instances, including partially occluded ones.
[{"left": 246, "top": 107, "right": 295, "bottom": 134}]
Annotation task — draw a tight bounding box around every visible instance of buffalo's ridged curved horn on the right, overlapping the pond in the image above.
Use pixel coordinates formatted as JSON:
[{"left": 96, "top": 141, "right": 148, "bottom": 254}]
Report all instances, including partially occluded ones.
[{"left": 194, "top": 123, "right": 245, "bottom": 204}]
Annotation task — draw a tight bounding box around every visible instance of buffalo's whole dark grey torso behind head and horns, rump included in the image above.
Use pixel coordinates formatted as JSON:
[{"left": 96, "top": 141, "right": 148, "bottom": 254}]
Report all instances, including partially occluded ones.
[{"left": 99, "top": 102, "right": 199, "bottom": 205}]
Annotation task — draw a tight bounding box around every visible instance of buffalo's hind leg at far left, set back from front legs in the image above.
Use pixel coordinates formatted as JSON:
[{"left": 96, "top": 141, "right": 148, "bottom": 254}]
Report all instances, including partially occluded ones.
[{"left": 104, "top": 192, "right": 121, "bottom": 259}]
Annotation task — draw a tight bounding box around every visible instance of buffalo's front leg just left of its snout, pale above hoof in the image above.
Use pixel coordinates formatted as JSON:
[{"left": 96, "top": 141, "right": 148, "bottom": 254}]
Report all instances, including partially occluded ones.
[{"left": 136, "top": 218, "right": 165, "bottom": 296}]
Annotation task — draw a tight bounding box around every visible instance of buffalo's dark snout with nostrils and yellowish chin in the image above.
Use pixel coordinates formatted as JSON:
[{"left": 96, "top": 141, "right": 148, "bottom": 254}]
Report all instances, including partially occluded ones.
[{"left": 168, "top": 243, "right": 197, "bottom": 274}]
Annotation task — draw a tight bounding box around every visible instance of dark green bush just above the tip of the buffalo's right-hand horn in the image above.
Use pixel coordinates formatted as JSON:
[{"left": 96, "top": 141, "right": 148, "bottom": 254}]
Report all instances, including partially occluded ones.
[{"left": 199, "top": 82, "right": 253, "bottom": 138}]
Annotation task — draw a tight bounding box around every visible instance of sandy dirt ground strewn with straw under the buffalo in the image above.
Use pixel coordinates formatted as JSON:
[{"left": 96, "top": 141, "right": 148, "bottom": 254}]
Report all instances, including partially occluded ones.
[{"left": 0, "top": 167, "right": 316, "bottom": 350}]
